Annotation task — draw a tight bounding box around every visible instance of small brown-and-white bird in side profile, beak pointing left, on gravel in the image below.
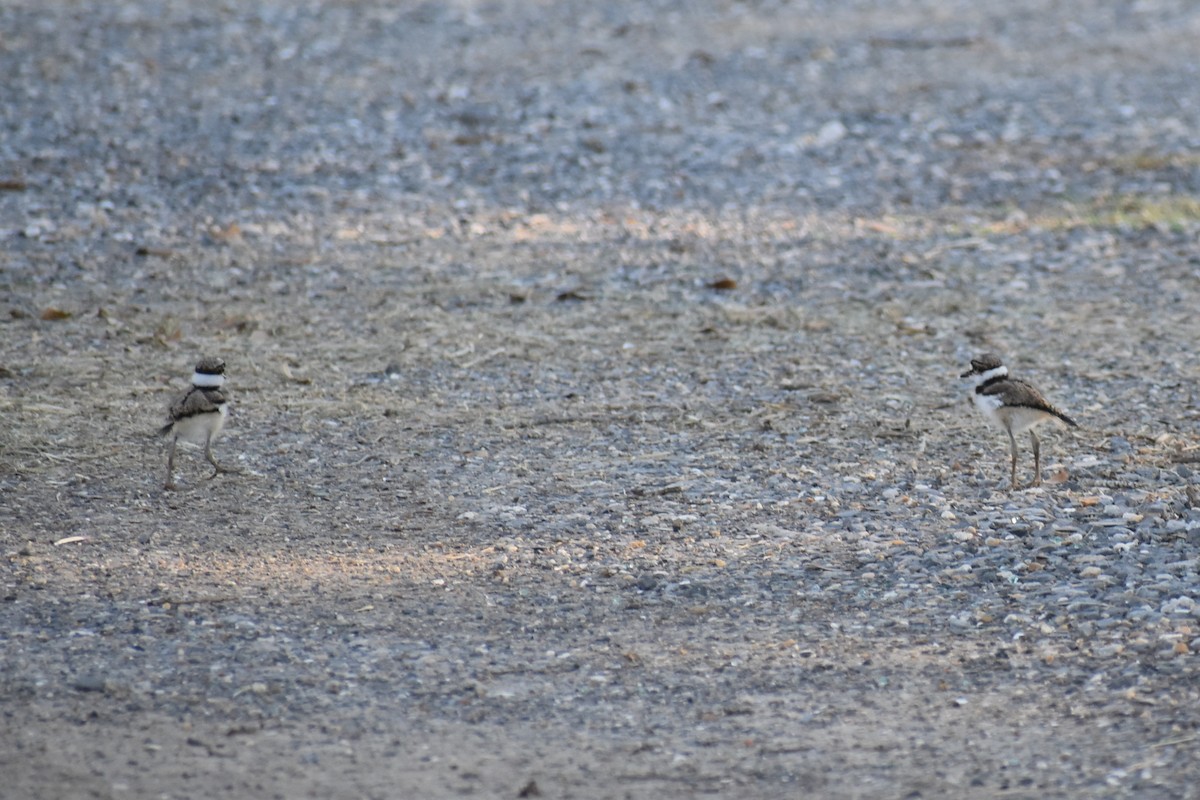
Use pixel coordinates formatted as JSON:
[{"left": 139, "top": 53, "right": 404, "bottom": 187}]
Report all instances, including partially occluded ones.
[{"left": 961, "top": 353, "right": 1079, "bottom": 489}]
